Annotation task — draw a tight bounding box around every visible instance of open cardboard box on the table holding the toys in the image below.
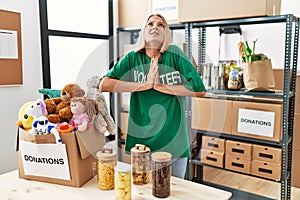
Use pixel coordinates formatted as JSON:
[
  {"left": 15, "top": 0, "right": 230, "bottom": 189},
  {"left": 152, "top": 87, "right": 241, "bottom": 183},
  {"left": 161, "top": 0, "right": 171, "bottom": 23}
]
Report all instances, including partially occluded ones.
[{"left": 17, "top": 126, "right": 105, "bottom": 187}]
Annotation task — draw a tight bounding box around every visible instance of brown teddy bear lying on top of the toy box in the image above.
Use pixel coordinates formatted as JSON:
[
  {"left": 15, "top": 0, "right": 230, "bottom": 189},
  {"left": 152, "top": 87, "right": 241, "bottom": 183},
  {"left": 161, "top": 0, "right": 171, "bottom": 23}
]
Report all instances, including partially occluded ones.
[{"left": 44, "top": 83, "right": 85, "bottom": 123}]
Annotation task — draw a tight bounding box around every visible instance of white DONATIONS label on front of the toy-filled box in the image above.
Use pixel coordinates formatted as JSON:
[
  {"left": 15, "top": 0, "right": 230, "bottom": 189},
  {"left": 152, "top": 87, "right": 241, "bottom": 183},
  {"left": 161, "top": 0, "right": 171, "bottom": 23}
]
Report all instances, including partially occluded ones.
[{"left": 20, "top": 140, "right": 71, "bottom": 180}]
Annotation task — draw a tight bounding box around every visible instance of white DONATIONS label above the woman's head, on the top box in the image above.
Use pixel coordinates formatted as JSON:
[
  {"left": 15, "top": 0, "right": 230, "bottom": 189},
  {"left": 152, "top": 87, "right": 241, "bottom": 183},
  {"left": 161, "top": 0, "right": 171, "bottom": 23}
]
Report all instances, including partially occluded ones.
[{"left": 152, "top": 0, "right": 178, "bottom": 20}]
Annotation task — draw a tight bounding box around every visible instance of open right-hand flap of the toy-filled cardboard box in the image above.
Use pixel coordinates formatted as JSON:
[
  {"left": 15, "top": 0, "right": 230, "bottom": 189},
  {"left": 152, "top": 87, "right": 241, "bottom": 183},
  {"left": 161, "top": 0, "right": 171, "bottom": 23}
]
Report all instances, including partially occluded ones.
[{"left": 76, "top": 125, "right": 105, "bottom": 159}]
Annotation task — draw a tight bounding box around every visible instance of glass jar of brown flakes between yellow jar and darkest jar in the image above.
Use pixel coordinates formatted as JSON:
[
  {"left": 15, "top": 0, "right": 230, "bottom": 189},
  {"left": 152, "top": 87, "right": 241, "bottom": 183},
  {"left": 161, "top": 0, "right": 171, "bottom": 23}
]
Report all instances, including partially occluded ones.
[{"left": 130, "top": 144, "right": 150, "bottom": 185}]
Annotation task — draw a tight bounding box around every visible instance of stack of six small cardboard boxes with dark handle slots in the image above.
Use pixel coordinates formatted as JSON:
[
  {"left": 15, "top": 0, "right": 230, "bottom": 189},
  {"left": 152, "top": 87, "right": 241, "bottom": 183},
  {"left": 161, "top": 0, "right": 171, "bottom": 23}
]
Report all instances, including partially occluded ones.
[{"left": 200, "top": 136, "right": 281, "bottom": 181}]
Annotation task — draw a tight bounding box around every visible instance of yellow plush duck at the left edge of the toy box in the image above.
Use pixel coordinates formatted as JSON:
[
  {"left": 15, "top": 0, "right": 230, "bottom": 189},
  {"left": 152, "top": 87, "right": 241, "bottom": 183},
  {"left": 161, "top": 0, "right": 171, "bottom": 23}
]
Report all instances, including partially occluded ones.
[{"left": 16, "top": 101, "right": 33, "bottom": 131}]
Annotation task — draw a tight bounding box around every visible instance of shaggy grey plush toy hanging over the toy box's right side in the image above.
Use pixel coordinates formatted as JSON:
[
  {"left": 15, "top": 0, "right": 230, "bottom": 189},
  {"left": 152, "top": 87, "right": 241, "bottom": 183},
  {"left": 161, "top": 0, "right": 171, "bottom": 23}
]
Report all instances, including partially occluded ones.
[{"left": 86, "top": 76, "right": 117, "bottom": 135}]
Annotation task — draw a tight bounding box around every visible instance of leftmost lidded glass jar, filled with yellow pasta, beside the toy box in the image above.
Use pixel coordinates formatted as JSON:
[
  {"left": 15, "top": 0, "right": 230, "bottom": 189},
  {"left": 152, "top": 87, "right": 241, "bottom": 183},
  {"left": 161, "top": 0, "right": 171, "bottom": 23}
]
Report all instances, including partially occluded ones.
[{"left": 96, "top": 149, "right": 117, "bottom": 190}]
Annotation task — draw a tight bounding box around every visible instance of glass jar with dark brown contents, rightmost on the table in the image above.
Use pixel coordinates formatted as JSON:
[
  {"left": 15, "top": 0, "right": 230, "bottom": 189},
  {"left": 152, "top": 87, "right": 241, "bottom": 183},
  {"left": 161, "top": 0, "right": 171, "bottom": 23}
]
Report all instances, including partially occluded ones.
[{"left": 151, "top": 152, "right": 172, "bottom": 198}]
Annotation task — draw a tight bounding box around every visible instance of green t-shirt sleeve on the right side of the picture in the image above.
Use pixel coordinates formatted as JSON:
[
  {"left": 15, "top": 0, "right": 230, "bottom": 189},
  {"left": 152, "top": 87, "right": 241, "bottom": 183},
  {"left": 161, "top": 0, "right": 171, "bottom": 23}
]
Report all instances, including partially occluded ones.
[{"left": 171, "top": 47, "right": 206, "bottom": 92}]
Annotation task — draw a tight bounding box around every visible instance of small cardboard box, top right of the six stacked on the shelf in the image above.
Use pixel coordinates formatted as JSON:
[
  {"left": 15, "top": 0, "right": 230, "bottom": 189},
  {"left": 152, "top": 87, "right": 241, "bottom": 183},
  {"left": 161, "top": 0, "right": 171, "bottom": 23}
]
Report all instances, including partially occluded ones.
[{"left": 252, "top": 144, "right": 282, "bottom": 164}]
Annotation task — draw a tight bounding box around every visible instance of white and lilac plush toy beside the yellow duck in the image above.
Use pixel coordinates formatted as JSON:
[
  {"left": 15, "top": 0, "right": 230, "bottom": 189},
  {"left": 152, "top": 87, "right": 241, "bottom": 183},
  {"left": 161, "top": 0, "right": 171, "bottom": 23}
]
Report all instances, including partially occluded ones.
[{"left": 25, "top": 99, "right": 47, "bottom": 134}]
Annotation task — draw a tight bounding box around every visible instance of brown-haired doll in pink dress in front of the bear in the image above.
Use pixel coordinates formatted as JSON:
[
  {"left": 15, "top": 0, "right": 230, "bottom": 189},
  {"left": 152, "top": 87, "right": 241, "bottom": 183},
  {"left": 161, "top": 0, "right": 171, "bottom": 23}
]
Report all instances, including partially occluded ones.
[{"left": 69, "top": 97, "right": 98, "bottom": 132}]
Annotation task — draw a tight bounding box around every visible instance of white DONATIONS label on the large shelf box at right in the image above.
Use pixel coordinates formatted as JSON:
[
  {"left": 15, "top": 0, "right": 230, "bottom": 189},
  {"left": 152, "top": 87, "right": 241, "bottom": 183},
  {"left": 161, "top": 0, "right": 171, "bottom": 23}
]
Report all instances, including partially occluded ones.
[{"left": 238, "top": 108, "right": 275, "bottom": 137}]
